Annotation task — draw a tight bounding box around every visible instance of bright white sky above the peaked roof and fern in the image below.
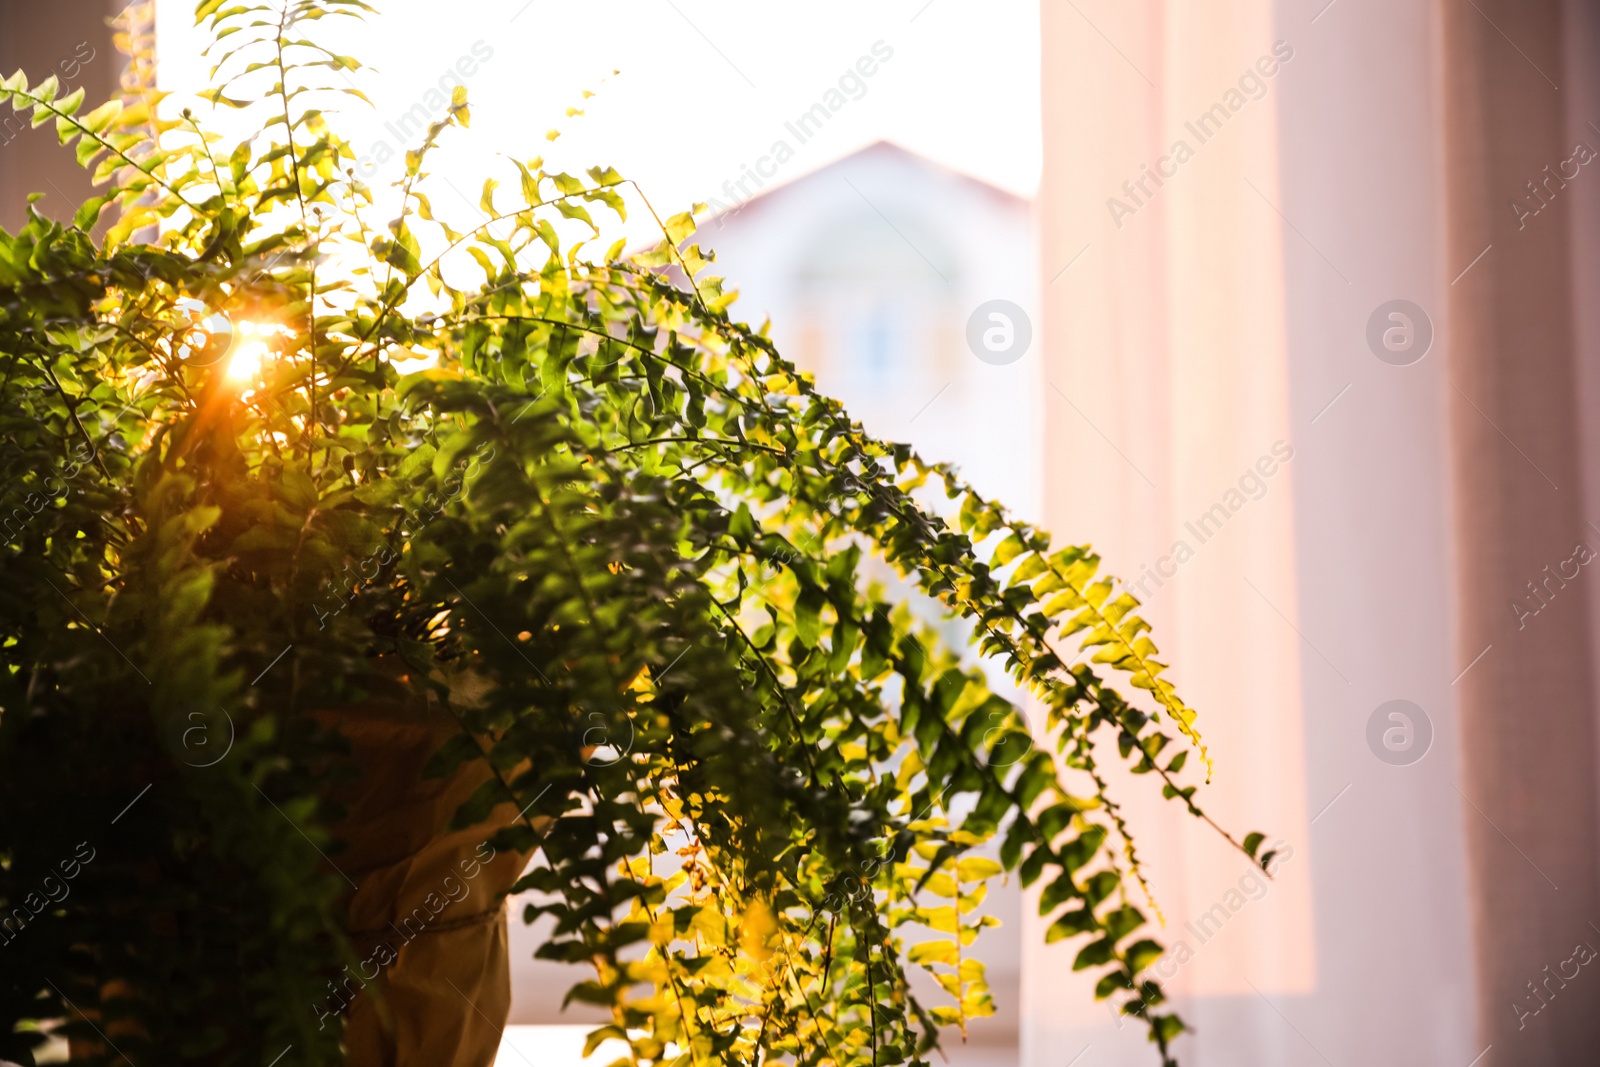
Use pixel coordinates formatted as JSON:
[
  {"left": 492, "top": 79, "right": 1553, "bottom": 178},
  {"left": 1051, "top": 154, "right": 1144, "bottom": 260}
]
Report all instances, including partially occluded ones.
[{"left": 157, "top": 0, "right": 1040, "bottom": 244}]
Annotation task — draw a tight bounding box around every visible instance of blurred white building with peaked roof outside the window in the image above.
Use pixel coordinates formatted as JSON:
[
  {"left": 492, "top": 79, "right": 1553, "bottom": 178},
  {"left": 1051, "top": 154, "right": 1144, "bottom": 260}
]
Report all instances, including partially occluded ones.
[{"left": 696, "top": 141, "right": 1040, "bottom": 531}]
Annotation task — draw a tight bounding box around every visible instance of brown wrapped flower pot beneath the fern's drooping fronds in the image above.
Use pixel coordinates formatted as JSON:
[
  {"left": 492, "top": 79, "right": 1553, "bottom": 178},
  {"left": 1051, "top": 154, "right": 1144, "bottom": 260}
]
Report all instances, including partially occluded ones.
[{"left": 312, "top": 687, "right": 528, "bottom": 1067}]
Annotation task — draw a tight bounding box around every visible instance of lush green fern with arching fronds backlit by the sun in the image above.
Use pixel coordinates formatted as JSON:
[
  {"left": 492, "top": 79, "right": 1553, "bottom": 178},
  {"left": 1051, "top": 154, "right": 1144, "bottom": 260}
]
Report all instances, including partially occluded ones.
[{"left": 0, "top": 0, "right": 1270, "bottom": 1067}]
